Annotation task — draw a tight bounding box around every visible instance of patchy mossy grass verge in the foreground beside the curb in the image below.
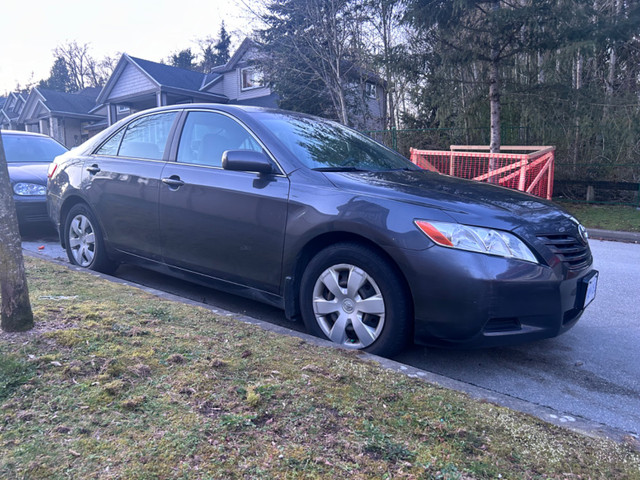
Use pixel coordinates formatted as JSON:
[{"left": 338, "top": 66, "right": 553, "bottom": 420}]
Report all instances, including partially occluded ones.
[{"left": 0, "top": 258, "right": 640, "bottom": 480}]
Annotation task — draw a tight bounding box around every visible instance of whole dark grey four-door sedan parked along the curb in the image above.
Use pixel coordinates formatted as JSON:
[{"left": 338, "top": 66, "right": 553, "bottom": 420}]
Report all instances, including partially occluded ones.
[{"left": 48, "top": 104, "right": 597, "bottom": 355}]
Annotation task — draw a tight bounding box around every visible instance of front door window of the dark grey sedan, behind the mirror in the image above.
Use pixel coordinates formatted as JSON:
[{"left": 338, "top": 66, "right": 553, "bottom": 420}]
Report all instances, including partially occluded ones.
[{"left": 177, "top": 112, "right": 263, "bottom": 167}]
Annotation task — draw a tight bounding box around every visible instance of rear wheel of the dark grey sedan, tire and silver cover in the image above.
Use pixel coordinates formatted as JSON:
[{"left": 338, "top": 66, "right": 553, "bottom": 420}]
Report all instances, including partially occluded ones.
[{"left": 64, "top": 203, "right": 118, "bottom": 274}]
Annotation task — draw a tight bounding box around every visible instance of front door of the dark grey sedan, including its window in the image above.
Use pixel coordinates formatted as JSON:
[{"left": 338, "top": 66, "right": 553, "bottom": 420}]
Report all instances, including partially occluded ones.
[{"left": 159, "top": 111, "right": 289, "bottom": 293}]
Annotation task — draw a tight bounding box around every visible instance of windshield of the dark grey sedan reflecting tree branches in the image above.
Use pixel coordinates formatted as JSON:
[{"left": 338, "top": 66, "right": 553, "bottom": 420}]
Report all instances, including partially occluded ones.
[{"left": 254, "top": 112, "right": 419, "bottom": 171}]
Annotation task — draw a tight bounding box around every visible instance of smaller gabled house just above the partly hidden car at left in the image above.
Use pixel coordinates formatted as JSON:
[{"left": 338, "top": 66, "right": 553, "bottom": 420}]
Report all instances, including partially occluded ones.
[{"left": 18, "top": 87, "right": 106, "bottom": 148}]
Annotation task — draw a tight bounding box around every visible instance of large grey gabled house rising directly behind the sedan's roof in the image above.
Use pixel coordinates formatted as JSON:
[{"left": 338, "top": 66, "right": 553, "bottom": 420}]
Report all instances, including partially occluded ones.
[{"left": 92, "top": 39, "right": 277, "bottom": 125}]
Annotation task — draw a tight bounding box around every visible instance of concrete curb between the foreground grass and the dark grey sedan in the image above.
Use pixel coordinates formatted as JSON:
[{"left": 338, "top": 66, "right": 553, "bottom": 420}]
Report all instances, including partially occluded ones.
[{"left": 23, "top": 248, "right": 640, "bottom": 451}]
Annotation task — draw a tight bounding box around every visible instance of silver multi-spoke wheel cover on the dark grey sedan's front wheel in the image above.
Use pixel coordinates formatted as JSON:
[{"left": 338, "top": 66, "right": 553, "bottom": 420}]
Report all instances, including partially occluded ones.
[{"left": 312, "top": 263, "right": 385, "bottom": 349}]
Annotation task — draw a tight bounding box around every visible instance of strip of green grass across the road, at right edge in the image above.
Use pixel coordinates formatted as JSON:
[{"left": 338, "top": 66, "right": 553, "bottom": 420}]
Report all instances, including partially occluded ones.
[{"left": 558, "top": 202, "right": 640, "bottom": 232}]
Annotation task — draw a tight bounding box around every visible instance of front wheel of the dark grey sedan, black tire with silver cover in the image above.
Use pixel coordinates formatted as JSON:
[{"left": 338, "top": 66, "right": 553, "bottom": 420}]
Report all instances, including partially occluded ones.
[{"left": 300, "top": 243, "right": 413, "bottom": 356}]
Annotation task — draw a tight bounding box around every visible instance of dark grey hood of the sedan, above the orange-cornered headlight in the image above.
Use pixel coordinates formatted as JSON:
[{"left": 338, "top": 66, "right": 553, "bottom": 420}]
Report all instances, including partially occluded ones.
[{"left": 325, "top": 170, "right": 570, "bottom": 230}]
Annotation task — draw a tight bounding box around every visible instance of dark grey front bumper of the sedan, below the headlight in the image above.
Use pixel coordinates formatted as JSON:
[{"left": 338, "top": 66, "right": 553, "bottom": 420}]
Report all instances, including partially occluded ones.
[{"left": 392, "top": 247, "right": 597, "bottom": 347}]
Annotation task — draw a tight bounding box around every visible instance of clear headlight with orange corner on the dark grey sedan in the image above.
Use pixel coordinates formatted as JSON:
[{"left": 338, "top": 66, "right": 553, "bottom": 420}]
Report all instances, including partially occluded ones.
[{"left": 415, "top": 220, "right": 538, "bottom": 263}]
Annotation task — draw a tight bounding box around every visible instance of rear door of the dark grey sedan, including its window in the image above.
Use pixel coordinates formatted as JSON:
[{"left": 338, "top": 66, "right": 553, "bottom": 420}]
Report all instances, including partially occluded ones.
[{"left": 84, "top": 111, "right": 178, "bottom": 260}]
